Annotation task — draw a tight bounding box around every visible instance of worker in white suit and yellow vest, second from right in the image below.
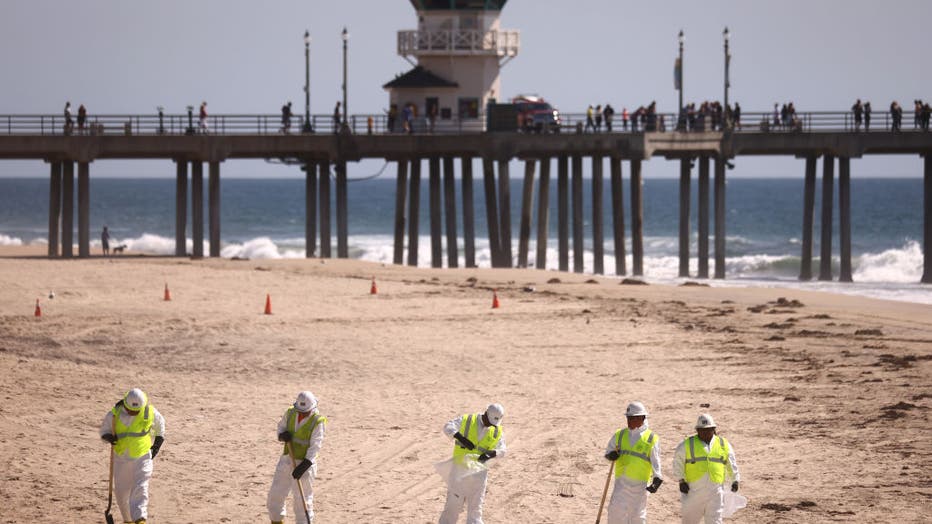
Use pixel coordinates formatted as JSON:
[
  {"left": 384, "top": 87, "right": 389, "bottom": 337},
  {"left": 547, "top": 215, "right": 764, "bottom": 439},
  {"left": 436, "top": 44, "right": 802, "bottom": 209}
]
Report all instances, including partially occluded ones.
[{"left": 605, "top": 402, "right": 663, "bottom": 524}]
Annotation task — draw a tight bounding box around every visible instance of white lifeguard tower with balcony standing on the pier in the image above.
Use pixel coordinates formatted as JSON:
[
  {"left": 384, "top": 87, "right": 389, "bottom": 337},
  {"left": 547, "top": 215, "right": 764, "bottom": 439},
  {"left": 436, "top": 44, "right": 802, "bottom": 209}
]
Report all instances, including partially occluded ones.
[{"left": 382, "top": 0, "right": 520, "bottom": 132}]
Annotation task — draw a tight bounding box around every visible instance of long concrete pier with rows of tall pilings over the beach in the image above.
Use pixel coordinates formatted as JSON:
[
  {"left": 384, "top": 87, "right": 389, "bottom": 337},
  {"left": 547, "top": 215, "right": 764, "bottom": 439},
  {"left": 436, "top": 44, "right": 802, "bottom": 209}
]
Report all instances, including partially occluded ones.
[{"left": 0, "top": 112, "right": 932, "bottom": 283}]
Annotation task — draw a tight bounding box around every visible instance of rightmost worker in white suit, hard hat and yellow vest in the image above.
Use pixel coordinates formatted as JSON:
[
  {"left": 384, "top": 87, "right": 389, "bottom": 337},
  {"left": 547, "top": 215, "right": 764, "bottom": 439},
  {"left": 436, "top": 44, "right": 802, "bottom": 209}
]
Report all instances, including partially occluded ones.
[{"left": 673, "top": 414, "right": 741, "bottom": 524}]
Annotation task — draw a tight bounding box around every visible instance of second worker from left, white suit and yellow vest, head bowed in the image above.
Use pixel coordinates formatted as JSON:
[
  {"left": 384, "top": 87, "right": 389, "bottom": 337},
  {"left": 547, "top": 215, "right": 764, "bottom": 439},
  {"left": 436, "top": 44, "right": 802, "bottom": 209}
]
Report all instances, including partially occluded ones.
[{"left": 267, "top": 391, "right": 327, "bottom": 524}]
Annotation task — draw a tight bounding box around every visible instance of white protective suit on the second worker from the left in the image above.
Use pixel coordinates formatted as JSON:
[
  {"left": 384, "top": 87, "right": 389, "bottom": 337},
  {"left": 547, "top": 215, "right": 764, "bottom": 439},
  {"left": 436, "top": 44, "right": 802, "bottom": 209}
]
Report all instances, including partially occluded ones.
[{"left": 267, "top": 408, "right": 326, "bottom": 524}]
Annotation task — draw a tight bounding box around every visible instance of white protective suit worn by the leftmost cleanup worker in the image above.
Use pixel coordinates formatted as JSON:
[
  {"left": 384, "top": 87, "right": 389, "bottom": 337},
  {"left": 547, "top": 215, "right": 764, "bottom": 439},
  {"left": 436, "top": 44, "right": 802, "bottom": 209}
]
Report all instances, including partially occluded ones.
[{"left": 100, "top": 404, "right": 165, "bottom": 522}]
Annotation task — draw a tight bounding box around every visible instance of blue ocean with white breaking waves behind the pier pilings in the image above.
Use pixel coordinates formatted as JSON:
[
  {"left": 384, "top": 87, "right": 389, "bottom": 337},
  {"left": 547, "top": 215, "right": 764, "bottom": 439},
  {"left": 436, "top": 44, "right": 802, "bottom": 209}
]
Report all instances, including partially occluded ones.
[{"left": 0, "top": 176, "right": 932, "bottom": 304}]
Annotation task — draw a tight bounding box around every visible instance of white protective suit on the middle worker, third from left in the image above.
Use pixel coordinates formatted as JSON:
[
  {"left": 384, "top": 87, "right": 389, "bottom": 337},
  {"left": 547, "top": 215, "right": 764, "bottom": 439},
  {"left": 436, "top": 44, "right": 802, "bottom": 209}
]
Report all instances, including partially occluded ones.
[{"left": 439, "top": 415, "right": 506, "bottom": 524}]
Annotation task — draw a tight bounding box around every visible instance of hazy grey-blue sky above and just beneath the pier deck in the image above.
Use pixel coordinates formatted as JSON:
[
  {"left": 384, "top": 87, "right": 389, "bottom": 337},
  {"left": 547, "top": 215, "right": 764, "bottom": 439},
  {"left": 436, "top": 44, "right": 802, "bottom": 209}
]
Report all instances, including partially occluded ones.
[{"left": 0, "top": 0, "right": 932, "bottom": 177}]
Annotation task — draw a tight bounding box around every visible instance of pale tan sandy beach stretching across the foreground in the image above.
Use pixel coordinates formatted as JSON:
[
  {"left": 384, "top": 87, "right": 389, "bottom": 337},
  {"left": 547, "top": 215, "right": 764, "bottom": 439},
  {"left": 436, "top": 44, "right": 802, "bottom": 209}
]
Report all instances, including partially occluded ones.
[{"left": 0, "top": 248, "right": 932, "bottom": 523}]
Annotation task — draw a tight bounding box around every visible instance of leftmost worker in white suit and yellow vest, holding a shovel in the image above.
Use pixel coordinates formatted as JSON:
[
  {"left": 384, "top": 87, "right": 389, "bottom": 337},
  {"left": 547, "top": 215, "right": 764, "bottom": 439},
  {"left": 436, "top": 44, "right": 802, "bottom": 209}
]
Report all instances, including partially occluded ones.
[{"left": 100, "top": 388, "right": 165, "bottom": 524}]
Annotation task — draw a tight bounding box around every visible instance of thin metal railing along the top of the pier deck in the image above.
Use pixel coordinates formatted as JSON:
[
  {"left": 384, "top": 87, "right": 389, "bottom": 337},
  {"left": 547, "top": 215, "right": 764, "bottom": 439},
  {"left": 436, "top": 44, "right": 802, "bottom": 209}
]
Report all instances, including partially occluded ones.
[{"left": 0, "top": 111, "right": 922, "bottom": 136}]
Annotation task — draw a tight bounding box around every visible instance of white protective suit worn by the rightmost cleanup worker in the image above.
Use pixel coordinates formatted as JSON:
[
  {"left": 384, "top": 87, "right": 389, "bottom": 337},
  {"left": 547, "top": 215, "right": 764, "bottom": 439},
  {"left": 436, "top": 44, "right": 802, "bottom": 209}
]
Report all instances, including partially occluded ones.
[{"left": 673, "top": 436, "right": 741, "bottom": 524}]
